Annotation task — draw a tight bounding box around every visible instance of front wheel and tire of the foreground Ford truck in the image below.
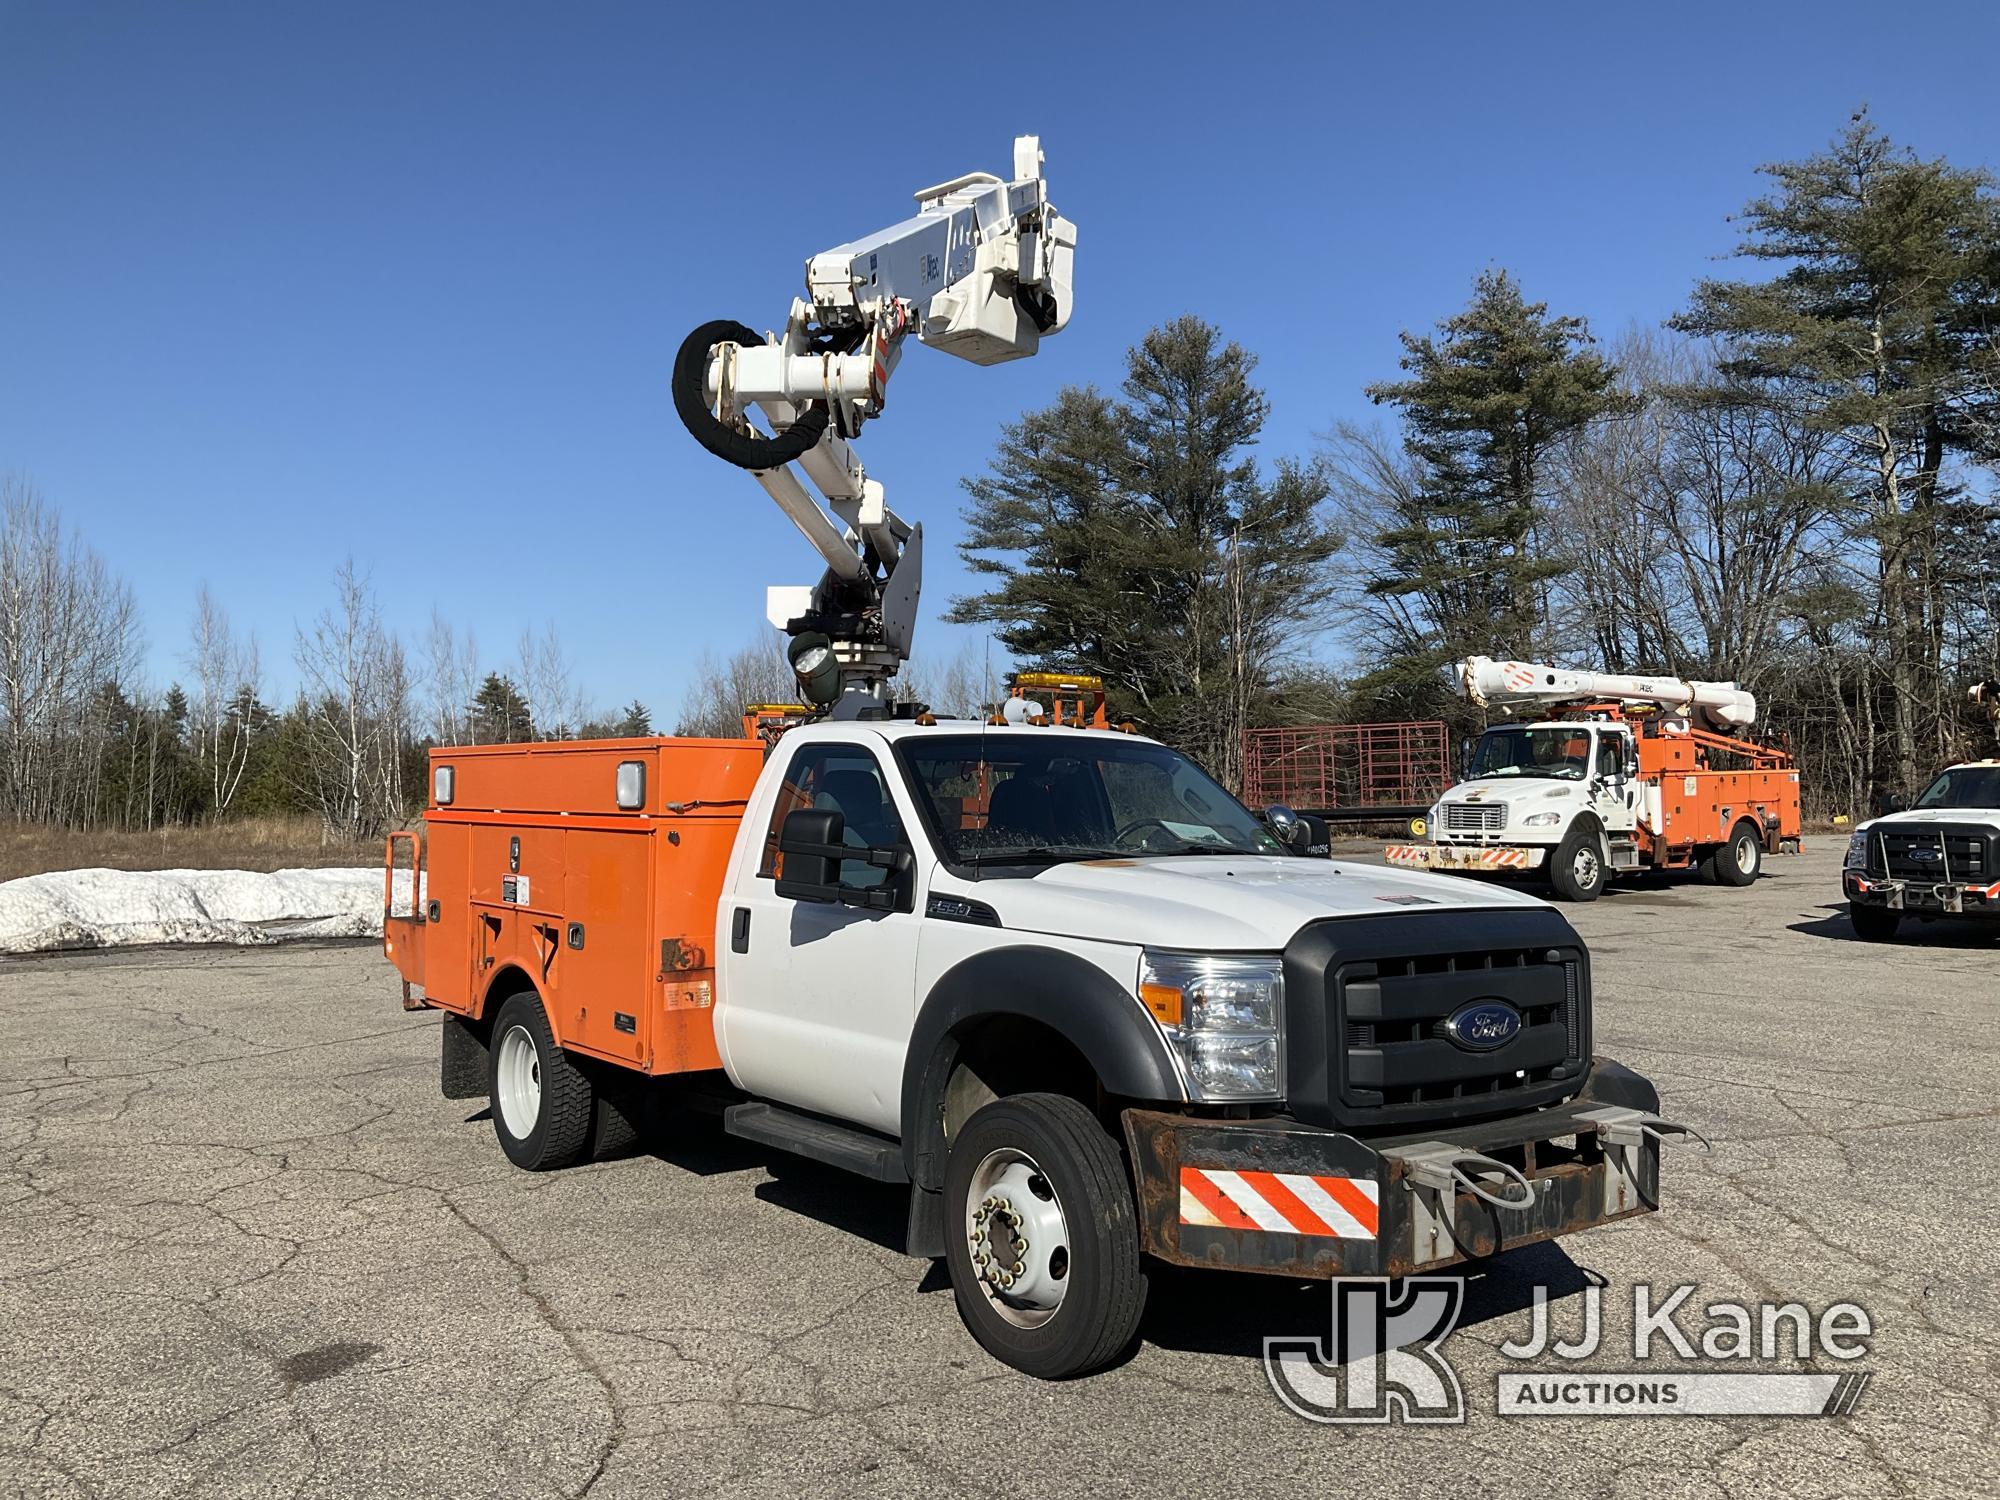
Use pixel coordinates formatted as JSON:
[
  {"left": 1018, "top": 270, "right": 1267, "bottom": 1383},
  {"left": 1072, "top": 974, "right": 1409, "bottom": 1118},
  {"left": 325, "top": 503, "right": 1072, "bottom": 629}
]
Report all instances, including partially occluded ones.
[{"left": 944, "top": 1094, "right": 1146, "bottom": 1380}]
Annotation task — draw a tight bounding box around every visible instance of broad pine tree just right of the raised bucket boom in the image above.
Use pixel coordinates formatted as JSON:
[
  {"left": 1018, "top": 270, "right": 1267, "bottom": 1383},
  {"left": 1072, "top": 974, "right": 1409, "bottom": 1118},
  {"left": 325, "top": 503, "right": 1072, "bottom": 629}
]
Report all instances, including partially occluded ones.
[{"left": 950, "top": 318, "right": 1338, "bottom": 780}]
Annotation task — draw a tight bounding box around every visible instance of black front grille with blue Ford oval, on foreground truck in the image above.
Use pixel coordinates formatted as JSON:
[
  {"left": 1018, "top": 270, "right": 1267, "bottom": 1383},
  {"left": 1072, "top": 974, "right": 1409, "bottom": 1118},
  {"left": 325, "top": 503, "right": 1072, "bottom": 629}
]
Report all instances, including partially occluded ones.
[{"left": 1286, "top": 910, "right": 1590, "bottom": 1128}]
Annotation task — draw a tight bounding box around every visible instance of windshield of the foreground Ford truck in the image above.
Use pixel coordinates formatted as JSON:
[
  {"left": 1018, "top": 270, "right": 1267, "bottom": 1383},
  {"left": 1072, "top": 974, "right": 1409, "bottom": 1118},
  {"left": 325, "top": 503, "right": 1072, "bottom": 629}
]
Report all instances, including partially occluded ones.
[{"left": 896, "top": 730, "right": 1286, "bottom": 866}]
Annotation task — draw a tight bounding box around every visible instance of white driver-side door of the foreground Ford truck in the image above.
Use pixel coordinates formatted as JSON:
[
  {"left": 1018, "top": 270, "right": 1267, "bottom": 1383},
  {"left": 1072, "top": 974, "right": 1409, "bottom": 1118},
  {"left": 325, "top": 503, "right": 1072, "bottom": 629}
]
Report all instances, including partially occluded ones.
[{"left": 716, "top": 742, "right": 930, "bottom": 1134}]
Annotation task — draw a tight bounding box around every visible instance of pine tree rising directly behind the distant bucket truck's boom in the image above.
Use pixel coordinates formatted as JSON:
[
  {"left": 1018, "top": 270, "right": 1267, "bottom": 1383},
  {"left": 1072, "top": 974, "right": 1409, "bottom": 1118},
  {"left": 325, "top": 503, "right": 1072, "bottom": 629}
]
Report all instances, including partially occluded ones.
[{"left": 1366, "top": 270, "right": 1618, "bottom": 676}]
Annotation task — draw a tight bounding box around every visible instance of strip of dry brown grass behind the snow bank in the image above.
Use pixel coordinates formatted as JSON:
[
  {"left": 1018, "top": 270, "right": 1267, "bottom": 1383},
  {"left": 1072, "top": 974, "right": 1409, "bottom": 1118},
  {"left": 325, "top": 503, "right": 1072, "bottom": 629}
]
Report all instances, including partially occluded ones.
[{"left": 0, "top": 816, "right": 382, "bottom": 880}]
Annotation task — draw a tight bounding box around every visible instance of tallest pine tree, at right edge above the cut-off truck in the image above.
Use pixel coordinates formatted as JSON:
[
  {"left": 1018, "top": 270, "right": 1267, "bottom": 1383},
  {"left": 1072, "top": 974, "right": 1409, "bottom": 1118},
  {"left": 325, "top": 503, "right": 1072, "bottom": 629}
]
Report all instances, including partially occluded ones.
[{"left": 1674, "top": 110, "right": 2000, "bottom": 792}]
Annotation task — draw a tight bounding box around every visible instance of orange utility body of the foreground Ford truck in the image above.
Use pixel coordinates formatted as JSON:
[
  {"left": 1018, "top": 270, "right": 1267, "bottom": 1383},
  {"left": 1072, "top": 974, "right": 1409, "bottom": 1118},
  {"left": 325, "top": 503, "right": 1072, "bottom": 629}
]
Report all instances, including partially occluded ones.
[{"left": 382, "top": 738, "right": 768, "bottom": 1076}]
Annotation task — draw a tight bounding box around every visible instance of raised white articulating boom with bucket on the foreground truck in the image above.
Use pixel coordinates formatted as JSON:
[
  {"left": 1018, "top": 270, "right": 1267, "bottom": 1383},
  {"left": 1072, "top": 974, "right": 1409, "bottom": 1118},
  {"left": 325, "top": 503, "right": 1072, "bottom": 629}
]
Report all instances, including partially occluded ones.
[{"left": 674, "top": 136, "right": 1076, "bottom": 718}]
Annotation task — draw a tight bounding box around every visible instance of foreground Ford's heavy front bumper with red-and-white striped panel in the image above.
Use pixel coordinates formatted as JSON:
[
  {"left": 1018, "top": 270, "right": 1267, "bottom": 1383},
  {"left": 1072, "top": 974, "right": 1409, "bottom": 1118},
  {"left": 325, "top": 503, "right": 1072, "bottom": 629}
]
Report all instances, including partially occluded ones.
[{"left": 1124, "top": 1060, "right": 1678, "bottom": 1278}]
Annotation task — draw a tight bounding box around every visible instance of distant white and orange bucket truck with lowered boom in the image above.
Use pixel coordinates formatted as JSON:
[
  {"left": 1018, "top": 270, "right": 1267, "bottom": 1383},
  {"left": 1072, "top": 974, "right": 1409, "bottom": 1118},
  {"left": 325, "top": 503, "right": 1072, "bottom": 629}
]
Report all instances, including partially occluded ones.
[{"left": 1388, "top": 656, "right": 1798, "bottom": 902}]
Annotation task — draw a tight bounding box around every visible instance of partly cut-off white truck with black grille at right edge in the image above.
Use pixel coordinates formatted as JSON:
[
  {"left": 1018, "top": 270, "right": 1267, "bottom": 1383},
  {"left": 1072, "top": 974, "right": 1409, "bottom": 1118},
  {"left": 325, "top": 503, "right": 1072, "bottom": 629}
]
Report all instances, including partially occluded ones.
[{"left": 1840, "top": 760, "right": 2000, "bottom": 942}]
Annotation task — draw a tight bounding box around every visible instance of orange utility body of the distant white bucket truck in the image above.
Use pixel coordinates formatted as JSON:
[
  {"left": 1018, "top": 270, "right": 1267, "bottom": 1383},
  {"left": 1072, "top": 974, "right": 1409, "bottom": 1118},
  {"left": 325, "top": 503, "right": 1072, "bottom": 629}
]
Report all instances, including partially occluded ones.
[{"left": 1566, "top": 704, "right": 1800, "bottom": 870}]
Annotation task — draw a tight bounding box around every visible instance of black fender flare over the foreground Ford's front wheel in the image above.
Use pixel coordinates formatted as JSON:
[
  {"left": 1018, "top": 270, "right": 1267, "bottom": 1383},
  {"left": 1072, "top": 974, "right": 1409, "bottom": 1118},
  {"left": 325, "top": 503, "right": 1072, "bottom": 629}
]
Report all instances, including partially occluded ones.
[{"left": 902, "top": 944, "right": 1186, "bottom": 1192}]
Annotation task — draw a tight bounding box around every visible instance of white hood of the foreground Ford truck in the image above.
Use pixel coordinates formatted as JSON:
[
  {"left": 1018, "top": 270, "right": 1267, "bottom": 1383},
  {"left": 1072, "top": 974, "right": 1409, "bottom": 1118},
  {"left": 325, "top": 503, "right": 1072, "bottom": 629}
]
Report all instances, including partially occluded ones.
[{"left": 962, "top": 854, "right": 1544, "bottom": 952}]
